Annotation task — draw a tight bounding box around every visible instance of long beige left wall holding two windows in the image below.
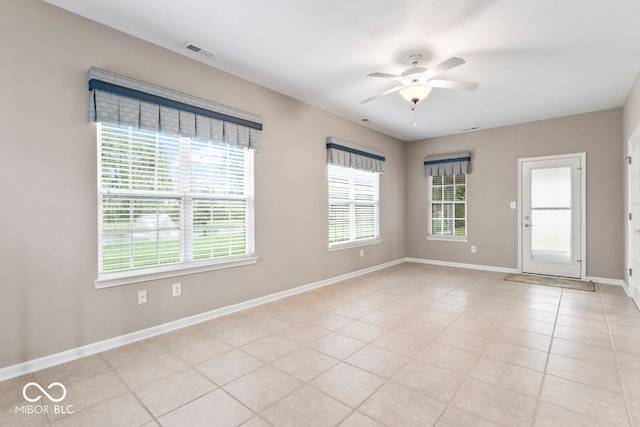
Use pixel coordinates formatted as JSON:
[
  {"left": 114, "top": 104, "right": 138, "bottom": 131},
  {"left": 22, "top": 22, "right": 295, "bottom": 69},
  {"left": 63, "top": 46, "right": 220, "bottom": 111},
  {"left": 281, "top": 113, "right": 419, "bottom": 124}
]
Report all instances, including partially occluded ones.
[{"left": 0, "top": 0, "right": 405, "bottom": 368}]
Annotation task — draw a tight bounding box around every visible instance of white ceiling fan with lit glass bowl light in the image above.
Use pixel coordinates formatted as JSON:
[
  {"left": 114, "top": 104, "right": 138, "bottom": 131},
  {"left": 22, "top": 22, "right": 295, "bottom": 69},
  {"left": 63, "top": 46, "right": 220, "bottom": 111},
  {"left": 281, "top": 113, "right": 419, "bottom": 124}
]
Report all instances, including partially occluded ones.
[{"left": 360, "top": 53, "right": 479, "bottom": 105}]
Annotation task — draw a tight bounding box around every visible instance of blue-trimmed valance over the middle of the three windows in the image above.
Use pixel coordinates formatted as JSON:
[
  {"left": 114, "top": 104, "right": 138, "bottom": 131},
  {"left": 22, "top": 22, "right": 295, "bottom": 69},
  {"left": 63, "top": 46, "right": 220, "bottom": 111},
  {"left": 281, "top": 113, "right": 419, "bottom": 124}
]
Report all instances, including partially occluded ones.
[{"left": 327, "top": 136, "right": 385, "bottom": 173}]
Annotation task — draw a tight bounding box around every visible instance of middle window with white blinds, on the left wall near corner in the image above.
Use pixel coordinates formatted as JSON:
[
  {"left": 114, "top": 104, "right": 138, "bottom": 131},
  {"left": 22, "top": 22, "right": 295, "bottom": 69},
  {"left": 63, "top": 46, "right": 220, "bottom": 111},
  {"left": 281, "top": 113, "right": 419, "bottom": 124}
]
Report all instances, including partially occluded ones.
[{"left": 328, "top": 164, "right": 380, "bottom": 248}]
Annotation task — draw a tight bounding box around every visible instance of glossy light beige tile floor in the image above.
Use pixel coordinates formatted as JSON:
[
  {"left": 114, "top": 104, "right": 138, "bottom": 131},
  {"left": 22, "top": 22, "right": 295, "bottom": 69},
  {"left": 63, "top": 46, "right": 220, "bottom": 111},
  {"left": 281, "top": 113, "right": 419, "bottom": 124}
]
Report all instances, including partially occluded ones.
[{"left": 0, "top": 263, "right": 640, "bottom": 427}]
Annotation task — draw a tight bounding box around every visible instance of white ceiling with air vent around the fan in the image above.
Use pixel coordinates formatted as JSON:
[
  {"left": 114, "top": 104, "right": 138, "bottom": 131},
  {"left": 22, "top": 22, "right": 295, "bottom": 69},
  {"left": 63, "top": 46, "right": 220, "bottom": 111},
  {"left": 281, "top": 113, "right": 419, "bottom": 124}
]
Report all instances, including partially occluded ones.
[{"left": 46, "top": 0, "right": 640, "bottom": 141}]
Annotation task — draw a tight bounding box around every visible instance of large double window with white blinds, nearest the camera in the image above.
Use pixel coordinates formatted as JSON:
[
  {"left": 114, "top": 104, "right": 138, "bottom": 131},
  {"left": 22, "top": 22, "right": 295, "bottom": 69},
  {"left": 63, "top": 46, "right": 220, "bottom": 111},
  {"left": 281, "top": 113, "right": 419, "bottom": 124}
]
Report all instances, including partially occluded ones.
[{"left": 97, "top": 123, "right": 254, "bottom": 279}]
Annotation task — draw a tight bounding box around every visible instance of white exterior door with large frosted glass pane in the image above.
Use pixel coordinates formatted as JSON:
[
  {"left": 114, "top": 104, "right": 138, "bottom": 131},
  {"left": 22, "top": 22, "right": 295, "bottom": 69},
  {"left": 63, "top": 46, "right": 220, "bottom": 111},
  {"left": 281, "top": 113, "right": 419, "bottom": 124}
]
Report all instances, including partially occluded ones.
[{"left": 518, "top": 153, "right": 586, "bottom": 279}]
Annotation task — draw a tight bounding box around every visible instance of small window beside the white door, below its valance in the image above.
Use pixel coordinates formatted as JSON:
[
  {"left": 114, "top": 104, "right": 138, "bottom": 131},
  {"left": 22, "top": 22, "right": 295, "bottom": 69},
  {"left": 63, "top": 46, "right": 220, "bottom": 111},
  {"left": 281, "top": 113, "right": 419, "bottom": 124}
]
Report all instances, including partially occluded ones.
[{"left": 429, "top": 174, "right": 467, "bottom": 240}]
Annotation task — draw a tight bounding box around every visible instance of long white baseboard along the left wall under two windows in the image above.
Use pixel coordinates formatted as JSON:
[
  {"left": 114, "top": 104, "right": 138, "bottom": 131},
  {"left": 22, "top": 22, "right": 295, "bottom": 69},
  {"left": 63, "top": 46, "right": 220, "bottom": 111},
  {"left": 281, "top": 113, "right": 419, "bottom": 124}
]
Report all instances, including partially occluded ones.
[{"left": 0, "top": 258, "right": 405, "bottom": 381}]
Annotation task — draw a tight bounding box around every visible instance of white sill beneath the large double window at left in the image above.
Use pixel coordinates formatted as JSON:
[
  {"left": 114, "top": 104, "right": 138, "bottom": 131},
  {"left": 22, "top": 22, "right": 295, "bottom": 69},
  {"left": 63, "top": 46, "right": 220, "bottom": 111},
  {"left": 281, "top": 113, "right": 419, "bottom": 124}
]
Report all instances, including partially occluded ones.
[{"left": 94, "top": 256, "right": 258, "bottom": 289}]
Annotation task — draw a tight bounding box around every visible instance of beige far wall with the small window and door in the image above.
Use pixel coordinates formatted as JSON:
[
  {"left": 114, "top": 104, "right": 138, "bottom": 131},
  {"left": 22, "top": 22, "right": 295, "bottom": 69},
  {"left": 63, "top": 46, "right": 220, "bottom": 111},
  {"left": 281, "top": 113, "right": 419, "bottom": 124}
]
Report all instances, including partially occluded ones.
[{"left": 405, "top": 109, "right": 624, "bottom": 279}]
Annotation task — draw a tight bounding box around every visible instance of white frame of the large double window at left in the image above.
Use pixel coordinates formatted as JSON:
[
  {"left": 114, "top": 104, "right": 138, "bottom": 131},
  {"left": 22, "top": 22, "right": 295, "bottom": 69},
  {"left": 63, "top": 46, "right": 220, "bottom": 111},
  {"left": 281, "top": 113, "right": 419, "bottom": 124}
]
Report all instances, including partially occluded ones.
[{"left": 95, "top": 123, "right": 258, "bottom": 288}]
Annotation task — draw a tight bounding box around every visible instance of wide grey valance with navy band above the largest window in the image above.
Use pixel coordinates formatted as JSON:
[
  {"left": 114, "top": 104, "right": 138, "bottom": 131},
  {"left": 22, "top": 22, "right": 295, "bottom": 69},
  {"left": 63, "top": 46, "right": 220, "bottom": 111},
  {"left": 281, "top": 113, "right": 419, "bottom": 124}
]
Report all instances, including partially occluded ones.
[{"left": 89, "top": 67, "right": 262, "bottom": 150}]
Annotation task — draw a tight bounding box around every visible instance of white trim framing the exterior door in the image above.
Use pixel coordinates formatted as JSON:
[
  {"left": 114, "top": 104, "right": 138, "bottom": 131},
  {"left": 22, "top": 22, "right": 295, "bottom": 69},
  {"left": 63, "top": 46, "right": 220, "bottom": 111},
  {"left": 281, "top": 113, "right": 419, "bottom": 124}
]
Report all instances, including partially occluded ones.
[{"left": 516, "top": 152, "right": 587, "bottom": 280}]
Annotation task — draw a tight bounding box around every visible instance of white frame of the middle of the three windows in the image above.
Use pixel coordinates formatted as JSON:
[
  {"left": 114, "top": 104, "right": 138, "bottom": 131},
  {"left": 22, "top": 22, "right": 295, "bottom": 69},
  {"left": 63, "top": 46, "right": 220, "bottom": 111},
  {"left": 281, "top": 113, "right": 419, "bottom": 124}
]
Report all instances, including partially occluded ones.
[{"left": 327, "top": 163, "right": 382, "bottom": 251}]
